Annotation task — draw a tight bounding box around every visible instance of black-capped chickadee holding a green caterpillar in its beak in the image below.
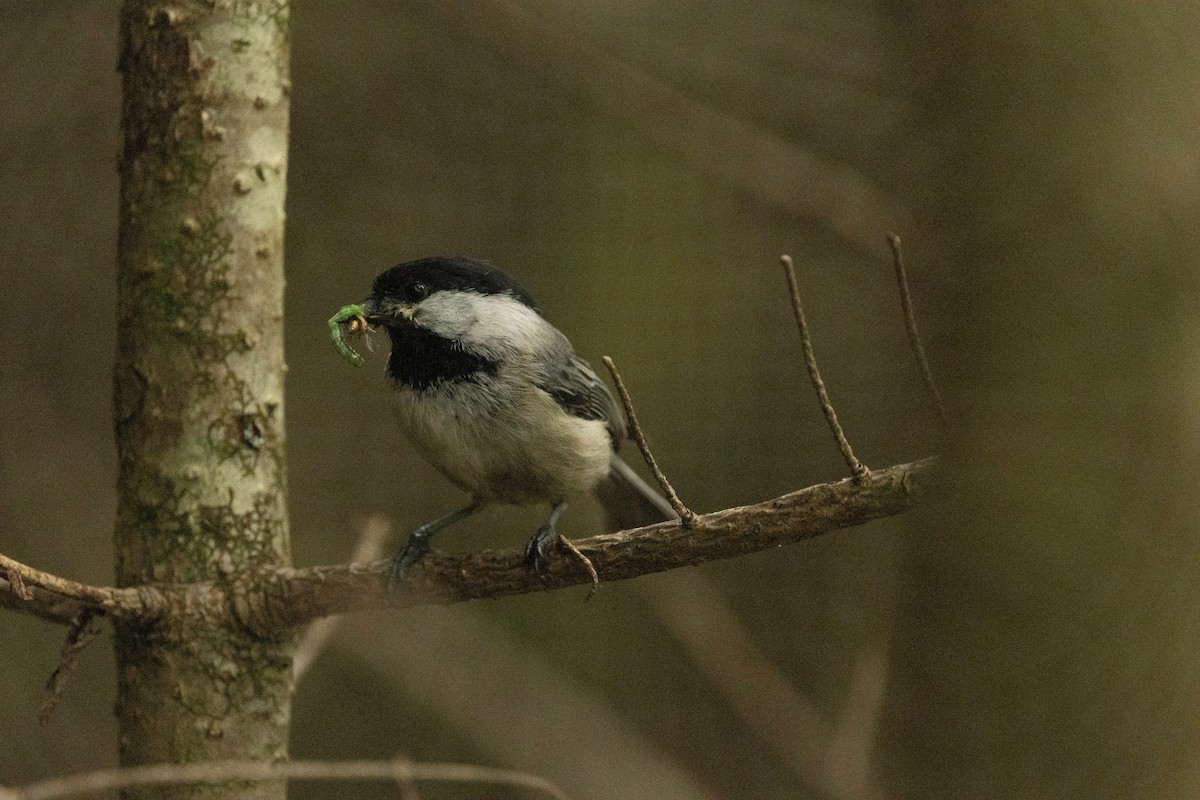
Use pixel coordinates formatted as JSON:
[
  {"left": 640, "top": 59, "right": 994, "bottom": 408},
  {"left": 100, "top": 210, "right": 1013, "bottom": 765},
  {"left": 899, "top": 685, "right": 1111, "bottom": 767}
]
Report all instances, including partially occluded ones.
[{"left": 330, "top": 257, "right": 674, "bottom": 584}]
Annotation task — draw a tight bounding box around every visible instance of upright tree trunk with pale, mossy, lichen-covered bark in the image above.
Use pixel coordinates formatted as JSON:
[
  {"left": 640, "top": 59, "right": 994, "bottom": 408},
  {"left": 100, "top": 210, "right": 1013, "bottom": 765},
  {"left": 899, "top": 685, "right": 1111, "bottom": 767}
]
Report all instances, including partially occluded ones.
[{"left": 115, "top": 0, "right": 292, "bottom": 798}]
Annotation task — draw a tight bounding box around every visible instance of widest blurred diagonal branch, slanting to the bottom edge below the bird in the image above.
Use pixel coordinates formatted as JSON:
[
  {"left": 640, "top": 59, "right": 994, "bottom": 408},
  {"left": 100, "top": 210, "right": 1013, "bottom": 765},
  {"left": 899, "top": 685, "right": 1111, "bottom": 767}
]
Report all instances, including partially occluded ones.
[{"left": 343, "top": 607, "right": 720, "bottom": 800}]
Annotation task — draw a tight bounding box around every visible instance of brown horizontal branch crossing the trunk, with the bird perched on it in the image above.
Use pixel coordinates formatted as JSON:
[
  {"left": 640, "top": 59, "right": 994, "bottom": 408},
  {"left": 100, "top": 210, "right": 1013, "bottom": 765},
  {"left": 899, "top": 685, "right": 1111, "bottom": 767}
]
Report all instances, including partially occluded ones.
[{"left": 0, "top": 458, "right": 937, "bottom": 633}]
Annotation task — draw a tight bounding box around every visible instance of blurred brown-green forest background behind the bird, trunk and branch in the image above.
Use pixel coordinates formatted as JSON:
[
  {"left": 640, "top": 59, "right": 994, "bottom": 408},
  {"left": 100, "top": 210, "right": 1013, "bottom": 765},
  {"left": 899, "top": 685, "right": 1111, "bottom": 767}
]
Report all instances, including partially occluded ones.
[{"left": 0, "top": 0, "right": 1200, "bottom": 800}]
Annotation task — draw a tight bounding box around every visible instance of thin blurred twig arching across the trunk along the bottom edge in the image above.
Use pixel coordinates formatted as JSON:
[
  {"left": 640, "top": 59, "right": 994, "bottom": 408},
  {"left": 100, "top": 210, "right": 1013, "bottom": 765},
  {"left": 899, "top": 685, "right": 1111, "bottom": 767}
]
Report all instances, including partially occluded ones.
[{"left": 0, "top": 759, "right": 568, "bottom": 800}]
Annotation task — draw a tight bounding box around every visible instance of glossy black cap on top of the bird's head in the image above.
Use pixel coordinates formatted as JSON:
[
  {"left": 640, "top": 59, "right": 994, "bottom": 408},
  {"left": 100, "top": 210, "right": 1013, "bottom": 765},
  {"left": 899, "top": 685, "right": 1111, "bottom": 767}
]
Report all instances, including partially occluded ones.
[{"left": 371, "top": 255, "right": 536, "bottom": 309}]
